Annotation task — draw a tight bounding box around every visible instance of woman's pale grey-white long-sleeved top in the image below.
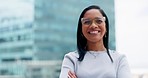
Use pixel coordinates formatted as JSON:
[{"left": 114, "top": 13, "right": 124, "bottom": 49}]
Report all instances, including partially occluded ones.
[{"left": 59, "top": 50, "right": 131, "bottom": 78}]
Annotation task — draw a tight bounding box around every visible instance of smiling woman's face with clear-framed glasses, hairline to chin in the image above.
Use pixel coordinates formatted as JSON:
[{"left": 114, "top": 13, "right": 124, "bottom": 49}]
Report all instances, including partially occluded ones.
[{"left": 81, "top": 9, "right": 106, "bottom": 42}]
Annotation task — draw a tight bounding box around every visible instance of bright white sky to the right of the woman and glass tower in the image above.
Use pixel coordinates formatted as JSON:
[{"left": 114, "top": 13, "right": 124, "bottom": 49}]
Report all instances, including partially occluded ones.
[{"left": 115, "top": 0, "right": 148, "bottom": 69}]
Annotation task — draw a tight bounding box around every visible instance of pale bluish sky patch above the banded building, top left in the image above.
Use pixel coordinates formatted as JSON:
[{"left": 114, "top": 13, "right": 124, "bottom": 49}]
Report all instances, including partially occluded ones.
[{"left": 0, "top": 0, "right": 34, "bottom": 19}]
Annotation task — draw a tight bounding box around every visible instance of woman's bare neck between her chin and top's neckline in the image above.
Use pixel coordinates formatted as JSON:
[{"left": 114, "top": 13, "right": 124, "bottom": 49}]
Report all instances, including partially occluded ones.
[{"left": 87, "top": 40, "right": 106, "bottom": 51}]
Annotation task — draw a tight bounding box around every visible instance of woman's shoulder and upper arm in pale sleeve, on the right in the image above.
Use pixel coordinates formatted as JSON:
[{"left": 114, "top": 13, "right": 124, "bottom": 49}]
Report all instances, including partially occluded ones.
[{"left": 110, "top": 50, "right": 131, "bottom": 78}]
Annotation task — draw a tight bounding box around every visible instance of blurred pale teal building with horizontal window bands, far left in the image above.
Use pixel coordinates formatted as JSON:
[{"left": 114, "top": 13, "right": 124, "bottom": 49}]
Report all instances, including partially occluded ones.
[{"left": 0, "top": 16, "right": 33, "bottom": 62}]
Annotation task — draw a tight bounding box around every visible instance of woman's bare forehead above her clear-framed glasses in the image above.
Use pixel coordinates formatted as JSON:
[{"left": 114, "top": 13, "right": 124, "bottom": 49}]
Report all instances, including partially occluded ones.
[{"left": 84, "top": 9, "right": 102, "bottom": 18}]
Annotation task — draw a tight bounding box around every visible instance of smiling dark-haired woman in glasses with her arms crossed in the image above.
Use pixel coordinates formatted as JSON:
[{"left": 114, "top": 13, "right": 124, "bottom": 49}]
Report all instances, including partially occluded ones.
[{"left": 60, "top": 5, "right": 130, "bottom": 78}]
